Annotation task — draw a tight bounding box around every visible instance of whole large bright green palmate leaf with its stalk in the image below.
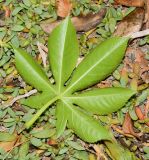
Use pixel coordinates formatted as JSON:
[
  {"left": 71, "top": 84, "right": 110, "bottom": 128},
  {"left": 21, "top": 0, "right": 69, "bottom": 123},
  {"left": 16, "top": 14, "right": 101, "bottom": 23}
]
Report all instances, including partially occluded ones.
[{"left": 14, "top": 17, "right": 134, "bottom": 142}]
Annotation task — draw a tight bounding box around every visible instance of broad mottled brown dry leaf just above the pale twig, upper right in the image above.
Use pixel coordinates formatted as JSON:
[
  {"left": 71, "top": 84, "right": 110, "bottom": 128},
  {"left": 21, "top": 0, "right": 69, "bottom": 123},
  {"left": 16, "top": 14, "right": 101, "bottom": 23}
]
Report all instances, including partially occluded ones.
[{"left": 114, "top": 8, "right": 145, "bottom": 36}]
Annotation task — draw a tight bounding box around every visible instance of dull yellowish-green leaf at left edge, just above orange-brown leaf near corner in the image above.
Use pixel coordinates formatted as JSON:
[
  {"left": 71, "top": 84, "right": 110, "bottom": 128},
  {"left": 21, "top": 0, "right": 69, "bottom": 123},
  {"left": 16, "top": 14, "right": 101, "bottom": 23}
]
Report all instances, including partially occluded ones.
[{"left": 0, "top": 132, "right": 16, "bottom": 142}]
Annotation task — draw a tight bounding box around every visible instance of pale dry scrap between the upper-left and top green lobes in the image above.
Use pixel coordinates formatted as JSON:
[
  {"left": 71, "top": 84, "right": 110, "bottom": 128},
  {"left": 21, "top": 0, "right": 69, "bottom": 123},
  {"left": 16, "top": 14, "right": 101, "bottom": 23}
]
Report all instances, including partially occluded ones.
[{"left": 37, "top": 42, "right": 48, "bottom": 67}]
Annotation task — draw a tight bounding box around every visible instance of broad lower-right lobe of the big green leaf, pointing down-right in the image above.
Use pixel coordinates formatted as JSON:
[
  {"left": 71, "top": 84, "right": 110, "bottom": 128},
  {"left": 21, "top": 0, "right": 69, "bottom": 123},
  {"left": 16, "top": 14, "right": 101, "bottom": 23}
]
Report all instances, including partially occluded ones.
[{"left": 60, "top": 101, "right": 112, "bottom": 143}]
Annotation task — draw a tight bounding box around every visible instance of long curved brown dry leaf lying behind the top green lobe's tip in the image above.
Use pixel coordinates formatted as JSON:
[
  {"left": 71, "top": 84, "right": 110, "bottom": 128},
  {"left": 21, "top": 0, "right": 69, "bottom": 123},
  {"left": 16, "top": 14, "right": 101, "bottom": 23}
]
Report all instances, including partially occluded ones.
[{"left": 40, "top": 9, "right": 106, "bottom": 33}]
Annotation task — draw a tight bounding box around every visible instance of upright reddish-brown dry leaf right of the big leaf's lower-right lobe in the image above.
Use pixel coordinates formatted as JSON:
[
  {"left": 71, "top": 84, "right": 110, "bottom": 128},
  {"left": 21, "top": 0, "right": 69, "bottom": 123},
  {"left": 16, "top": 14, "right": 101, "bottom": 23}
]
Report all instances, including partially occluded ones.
[{"left": 122, "top": 113, "right": 138, "bottom": 137}]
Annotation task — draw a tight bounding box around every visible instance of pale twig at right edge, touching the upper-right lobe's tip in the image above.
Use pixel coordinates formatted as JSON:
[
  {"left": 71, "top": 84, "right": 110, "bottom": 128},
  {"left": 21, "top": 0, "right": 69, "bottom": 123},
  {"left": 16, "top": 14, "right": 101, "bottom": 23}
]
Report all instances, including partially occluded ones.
[{"left": 126, "top": 29, "right": 149, "bottom": 39}]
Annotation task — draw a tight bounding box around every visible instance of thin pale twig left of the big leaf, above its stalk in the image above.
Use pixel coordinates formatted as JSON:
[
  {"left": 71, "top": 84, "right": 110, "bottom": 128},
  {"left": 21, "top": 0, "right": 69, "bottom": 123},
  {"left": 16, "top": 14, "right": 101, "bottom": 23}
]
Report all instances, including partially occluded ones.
[{"left": 3, "top": 89, "right": 37, "bottom": 107}]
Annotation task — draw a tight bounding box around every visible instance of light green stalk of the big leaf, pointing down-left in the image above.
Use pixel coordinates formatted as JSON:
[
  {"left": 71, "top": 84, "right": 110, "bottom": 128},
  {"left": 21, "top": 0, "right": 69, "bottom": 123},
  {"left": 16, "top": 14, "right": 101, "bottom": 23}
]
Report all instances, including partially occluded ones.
[{"left": 25, "top": 96, "right": 59, "bottom": 129}]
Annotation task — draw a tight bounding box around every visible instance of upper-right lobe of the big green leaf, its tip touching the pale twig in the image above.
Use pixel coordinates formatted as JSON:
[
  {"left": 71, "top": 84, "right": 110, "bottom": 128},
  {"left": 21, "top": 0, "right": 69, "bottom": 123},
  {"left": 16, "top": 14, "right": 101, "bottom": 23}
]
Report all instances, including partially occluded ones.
[{"left": 65, "top": 37, "right": 128, "bottom": 93}]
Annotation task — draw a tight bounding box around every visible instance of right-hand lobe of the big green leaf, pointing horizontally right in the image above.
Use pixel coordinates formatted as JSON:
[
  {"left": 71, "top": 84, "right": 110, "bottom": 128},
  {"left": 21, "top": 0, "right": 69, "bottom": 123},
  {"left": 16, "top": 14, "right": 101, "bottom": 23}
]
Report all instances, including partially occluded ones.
[{"left": 68, "top": 88, "right": 135, "bottom": 115}]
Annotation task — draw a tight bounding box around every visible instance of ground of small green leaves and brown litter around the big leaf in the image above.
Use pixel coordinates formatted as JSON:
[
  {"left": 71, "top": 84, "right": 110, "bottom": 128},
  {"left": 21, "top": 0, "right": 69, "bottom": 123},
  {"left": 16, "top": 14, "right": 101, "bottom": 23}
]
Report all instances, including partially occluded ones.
[{"left": 0, "top": 1, "right": 149, "bottom": 160}]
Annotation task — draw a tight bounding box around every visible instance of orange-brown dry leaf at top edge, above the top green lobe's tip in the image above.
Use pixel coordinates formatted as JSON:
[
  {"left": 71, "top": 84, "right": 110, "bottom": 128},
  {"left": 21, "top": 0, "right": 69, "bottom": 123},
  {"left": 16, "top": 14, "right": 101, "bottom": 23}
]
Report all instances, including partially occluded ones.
[{"left": 57, "top": 0, "right": 72, "bottom": 18}]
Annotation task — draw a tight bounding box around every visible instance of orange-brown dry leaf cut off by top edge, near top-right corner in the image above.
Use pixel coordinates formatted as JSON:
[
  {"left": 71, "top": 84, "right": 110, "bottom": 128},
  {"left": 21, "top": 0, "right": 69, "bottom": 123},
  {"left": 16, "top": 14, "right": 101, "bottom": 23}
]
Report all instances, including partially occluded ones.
[{"left": 114, "top": 0, "right": 144, "bottom": 7}]
